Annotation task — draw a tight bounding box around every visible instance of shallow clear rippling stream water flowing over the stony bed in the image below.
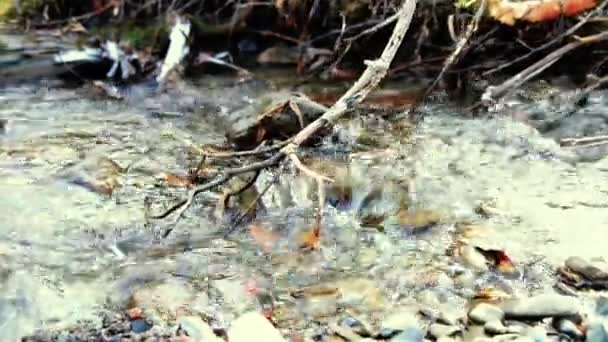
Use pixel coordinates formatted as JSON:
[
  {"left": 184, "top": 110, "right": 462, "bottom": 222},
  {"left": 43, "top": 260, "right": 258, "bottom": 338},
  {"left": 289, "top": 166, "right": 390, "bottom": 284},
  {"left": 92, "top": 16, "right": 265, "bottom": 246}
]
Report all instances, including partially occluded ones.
[{"left": 0, "top": 72, "right": 608, "bottom": 341}]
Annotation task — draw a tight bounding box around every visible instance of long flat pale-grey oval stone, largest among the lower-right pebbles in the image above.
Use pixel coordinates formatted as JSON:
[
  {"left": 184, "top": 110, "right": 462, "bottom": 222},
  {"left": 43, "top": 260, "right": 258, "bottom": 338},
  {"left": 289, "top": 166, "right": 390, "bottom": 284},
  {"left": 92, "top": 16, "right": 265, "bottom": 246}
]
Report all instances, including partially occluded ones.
[{"left": 500, "top": 294, "right": 580, "bottom": 320}]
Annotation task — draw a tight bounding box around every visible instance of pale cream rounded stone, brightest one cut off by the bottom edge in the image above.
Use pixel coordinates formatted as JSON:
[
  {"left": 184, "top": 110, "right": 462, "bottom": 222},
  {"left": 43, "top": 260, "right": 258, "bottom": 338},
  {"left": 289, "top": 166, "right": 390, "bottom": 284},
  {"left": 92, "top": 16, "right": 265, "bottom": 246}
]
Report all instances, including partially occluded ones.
[{"left": 228, "top": 311, "right": 287, "bottom": 342}]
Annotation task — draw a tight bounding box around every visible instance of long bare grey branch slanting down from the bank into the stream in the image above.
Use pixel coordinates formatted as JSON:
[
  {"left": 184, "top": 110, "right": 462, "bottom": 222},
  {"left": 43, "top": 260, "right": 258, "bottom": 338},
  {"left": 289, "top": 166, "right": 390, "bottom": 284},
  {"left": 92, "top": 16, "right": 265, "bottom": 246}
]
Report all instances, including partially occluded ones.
[{"left": 151, "top": 0, "right": 416, "bottom": 237}]
